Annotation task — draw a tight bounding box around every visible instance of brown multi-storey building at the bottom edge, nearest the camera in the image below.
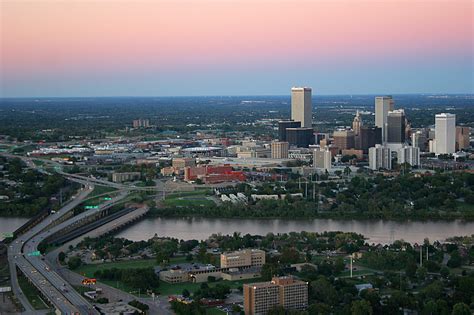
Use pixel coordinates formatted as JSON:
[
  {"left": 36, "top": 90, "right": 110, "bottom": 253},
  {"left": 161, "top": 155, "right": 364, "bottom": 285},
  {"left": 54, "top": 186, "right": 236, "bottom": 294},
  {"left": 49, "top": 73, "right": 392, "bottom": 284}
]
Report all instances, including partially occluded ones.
[{"left": 243, "top": 277, "right": 308, "bottom": 315}]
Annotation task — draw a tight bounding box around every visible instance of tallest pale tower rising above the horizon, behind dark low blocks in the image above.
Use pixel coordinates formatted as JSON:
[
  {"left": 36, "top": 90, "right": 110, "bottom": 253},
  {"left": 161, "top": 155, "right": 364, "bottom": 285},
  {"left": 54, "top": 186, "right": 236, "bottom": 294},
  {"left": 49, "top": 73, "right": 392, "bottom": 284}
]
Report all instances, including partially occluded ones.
[{"left": 291, "top": 87, "right": 313, "bottom": 128}]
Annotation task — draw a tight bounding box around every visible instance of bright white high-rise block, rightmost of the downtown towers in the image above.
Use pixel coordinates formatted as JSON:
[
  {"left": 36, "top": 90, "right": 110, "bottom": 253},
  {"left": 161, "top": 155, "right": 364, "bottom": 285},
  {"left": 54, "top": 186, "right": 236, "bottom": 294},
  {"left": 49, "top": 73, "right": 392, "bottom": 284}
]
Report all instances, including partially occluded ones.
[{"left": 434, "top": 113, "right": 456, "bottom": 155}]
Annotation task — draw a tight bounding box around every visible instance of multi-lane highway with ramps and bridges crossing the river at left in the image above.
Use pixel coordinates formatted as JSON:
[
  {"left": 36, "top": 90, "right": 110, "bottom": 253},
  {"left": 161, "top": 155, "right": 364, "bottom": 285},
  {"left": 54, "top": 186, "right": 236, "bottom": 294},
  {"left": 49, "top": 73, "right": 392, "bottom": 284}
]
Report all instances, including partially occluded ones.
[{"left": 0, "top": 153, "right": 163, "bottom": 314}]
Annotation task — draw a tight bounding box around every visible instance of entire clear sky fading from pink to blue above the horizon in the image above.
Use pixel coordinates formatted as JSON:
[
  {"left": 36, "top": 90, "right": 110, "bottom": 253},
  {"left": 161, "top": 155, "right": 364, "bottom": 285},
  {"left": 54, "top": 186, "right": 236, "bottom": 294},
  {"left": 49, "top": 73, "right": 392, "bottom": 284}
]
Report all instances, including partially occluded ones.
[{"left": 0, "top": 0, "right": 474, "bottom": 97}]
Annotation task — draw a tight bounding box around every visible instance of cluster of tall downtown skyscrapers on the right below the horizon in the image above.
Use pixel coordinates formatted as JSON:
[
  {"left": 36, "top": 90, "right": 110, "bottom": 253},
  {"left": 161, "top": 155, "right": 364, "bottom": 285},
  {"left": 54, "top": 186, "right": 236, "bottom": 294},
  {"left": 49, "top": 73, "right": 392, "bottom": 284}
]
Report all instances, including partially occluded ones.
[{"left": 271, "top": 87, "right": 470, "bottom": 172}]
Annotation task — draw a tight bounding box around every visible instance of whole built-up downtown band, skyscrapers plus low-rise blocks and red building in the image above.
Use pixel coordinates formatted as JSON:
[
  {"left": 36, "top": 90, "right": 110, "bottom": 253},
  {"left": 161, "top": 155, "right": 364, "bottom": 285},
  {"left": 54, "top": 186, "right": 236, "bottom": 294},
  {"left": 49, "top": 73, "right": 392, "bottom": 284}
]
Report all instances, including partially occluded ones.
[{"left": 28, "top": 87, "right": 470, "bottom": 184}]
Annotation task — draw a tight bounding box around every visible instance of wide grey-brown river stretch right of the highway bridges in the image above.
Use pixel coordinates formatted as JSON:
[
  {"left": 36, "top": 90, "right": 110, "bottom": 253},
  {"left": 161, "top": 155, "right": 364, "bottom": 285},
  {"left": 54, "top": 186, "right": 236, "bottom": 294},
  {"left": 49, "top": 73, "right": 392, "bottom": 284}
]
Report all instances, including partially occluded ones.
[{"left": 117, "top": 218, "right": 474, "bottom": 244}]
